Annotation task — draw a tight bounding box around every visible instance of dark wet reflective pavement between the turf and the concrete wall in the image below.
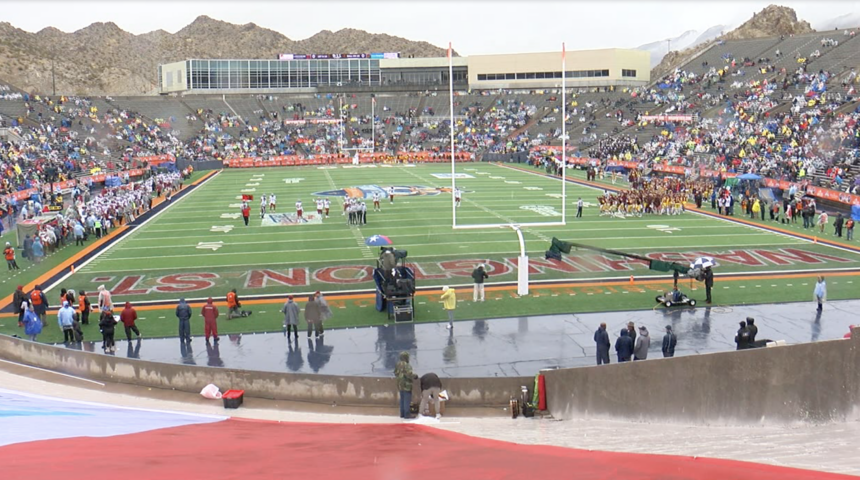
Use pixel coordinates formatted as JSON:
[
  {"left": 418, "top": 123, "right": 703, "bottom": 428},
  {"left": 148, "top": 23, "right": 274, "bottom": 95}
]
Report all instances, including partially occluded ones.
[{"left": 62, "top": 300, "right": 860, "bottom": 378}]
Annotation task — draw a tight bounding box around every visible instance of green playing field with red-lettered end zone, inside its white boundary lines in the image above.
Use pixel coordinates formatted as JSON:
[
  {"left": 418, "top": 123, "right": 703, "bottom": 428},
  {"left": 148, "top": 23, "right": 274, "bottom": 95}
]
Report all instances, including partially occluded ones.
[{"left": 62, "top": 164, "right": 860, "bottom": 302}]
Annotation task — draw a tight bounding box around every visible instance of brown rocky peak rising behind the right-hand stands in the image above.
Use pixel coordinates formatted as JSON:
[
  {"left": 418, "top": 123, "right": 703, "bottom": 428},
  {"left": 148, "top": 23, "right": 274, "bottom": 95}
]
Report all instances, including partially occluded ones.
[{"left": 651, "top": 5, "right": 815, "bottom": 79}]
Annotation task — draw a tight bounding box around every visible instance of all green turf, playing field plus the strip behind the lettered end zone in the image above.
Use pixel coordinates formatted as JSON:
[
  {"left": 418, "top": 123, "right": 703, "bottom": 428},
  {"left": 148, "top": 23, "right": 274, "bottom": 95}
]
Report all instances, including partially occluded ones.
[{"left": 6, "top": 164, "right": 860, "bottom": 341}]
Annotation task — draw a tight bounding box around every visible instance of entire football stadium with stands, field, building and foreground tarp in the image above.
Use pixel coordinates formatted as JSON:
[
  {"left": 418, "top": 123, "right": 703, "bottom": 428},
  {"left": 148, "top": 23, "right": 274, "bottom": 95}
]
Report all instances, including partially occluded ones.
[{"left": 0, "top": 6, "right": 860, "bottom": 479}]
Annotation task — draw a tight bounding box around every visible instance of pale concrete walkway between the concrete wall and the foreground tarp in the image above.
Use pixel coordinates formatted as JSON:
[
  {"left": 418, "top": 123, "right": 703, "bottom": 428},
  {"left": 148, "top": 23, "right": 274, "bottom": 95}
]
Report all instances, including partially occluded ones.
[{"left": 0, "top": 362, "right": 860, "bottom": 475}]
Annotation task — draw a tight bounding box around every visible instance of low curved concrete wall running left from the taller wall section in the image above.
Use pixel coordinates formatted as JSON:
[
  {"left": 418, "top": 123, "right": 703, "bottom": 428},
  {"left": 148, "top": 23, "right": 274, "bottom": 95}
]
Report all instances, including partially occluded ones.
[{"left": 0, "top": 335, "right": 534, "bottom": 407}]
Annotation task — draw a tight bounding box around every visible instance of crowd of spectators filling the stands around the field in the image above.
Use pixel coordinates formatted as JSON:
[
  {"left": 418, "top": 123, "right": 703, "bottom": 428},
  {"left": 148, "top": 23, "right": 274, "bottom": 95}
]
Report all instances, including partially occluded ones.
[{"left": 0, "top": 48, "right": 860, "bottom": 204}]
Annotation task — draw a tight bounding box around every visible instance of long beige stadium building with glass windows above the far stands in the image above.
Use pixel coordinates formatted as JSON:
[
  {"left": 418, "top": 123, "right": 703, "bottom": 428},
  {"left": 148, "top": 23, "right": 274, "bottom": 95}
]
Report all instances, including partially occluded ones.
[{"left": 158, "top": 48, "right": 651, "bottom": 94}]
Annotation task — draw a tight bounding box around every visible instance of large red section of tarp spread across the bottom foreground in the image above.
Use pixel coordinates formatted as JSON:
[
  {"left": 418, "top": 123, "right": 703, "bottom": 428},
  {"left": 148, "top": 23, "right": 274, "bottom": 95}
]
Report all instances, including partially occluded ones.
[{"left": 0, "top": 417, "right": 856, "bottom": 480}]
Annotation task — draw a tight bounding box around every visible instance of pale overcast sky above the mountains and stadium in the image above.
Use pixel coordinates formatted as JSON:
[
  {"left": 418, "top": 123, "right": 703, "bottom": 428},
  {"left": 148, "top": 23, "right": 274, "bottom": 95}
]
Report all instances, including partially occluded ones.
[{"left": 0, "top": 0, "right": 860, "bottom": 55}]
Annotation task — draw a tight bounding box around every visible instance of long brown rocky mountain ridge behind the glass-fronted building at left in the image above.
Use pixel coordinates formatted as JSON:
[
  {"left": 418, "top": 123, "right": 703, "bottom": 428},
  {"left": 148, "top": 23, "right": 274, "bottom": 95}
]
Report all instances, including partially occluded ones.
[{"left": 0, "top": 16, "right": 446, "bottom": 95}]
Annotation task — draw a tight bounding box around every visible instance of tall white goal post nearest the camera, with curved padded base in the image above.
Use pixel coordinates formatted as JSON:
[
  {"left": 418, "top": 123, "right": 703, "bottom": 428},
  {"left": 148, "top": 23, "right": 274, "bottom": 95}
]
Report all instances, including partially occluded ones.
[{"left": 448, "top": 42, "right": 567, "bottom": 296}]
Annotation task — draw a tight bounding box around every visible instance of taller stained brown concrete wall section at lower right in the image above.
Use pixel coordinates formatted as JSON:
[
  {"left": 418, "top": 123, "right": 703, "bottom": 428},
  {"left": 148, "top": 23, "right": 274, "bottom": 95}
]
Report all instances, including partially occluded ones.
[{"left": 544, "top": 329, "right": 860, "bottom": 424}]
